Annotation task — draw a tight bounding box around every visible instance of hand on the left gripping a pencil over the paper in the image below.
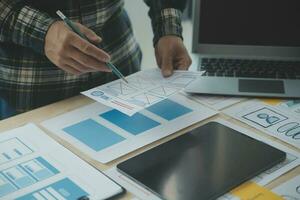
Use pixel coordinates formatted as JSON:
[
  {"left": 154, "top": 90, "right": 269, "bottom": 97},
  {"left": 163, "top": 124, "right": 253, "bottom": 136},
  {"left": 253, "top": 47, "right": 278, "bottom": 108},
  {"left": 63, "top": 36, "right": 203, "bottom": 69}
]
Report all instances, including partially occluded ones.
[{"left": 44, "top": 21, "right": 111, "bottom": 75}]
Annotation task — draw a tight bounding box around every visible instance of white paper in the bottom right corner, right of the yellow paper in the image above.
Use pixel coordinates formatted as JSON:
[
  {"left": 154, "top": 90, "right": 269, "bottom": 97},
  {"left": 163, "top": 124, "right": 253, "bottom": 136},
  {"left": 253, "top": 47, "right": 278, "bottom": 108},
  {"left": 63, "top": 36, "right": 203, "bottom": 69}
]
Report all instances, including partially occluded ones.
[{"left": 272, "top": 175, "right": 300, "bottom": 200}]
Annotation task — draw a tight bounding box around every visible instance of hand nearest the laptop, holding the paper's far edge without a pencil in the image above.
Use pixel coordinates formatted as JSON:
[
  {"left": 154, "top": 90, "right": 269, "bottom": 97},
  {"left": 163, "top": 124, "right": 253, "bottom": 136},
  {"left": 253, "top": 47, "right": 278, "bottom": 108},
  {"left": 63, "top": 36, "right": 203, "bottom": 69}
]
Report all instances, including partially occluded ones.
[{"left": 155, "top": 35, "right": 192, "bottom": 77}]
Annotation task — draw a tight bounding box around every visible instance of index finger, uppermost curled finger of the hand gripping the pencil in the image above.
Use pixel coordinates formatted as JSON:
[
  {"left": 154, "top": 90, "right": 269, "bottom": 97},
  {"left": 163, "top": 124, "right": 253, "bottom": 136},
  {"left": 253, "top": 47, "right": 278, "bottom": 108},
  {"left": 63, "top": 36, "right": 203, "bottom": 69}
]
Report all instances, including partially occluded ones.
[{"left": 70, "top": 34, "right": 110, "bottom": 62}]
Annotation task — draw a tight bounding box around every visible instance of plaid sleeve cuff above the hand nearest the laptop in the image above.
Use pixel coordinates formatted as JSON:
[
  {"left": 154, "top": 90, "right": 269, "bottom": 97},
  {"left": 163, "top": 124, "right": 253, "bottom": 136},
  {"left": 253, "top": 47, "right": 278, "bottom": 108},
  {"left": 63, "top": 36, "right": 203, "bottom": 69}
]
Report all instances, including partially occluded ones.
[{"left": 144, "top": 0, "right": 186, "bottom": 45}]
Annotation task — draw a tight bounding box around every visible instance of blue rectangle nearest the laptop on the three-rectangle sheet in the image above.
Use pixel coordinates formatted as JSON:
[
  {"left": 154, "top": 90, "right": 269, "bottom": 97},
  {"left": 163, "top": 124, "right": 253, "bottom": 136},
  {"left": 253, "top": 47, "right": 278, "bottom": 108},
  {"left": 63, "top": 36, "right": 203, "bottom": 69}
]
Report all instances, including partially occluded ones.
[{"left": 146, "top": 99, "right": 192, "bottom": 121}]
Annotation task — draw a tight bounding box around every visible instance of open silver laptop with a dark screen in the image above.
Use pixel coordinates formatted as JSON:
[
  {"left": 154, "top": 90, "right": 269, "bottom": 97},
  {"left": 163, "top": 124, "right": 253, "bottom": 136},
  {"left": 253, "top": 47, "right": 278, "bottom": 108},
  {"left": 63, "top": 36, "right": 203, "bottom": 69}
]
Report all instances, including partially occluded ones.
[{"left": 186, "top": 0, "right": 300, "bottom": 98}]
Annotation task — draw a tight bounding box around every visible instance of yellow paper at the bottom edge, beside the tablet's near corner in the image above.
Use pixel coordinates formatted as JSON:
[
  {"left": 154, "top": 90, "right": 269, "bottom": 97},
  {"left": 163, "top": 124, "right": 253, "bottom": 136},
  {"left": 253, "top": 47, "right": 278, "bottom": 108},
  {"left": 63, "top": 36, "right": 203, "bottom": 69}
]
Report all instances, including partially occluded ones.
[{"left": 231, "top": 182, "right": 283, "bottom": 200}]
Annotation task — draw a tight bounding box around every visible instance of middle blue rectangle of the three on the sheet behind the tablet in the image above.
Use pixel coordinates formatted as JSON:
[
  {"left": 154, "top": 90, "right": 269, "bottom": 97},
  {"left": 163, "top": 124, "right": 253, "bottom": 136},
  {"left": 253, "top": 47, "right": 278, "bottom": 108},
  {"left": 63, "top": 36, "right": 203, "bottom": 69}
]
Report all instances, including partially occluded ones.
[{"left": 100, "top": 110, "right": 160, "bottom": 135}]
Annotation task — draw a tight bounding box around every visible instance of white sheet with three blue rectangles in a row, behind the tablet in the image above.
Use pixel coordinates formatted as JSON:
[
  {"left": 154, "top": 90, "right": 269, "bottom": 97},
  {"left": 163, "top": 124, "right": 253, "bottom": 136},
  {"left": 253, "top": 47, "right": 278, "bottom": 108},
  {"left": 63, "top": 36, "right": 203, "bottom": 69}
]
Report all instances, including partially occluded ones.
[{"left": 42, "top": 94, "right": 217, "bottom": 163}]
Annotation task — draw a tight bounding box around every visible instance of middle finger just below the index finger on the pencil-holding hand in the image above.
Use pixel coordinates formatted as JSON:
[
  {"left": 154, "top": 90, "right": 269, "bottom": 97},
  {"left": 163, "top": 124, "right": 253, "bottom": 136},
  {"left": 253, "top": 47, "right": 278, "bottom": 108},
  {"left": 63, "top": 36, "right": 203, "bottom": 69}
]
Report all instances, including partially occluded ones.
[{"left": 69, "top": 48, "right": 111, "bottom": 72}]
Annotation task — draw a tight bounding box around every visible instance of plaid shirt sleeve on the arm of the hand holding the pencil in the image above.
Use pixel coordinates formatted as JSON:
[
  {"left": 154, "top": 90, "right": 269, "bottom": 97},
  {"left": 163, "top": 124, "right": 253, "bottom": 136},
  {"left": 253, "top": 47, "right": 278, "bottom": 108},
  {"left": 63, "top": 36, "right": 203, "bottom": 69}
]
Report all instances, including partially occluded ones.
[{"left": 0, "top": 0, "right": 55, "bottom": 54}]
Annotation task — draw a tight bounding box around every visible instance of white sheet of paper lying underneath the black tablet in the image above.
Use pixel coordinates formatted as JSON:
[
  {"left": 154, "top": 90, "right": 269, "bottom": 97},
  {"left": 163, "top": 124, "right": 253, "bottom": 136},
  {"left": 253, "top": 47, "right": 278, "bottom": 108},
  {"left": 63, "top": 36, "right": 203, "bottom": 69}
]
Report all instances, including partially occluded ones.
[{"left": 104, "top": 119, "right": 300, "bottom": 200}]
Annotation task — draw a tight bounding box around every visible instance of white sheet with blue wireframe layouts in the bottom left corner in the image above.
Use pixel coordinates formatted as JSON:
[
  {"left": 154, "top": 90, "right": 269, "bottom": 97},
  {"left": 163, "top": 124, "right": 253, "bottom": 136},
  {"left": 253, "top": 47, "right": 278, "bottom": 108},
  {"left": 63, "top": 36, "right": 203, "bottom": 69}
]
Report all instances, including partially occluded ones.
[{"left": 0, "top": 124, "right": 122, "bottom": 200}]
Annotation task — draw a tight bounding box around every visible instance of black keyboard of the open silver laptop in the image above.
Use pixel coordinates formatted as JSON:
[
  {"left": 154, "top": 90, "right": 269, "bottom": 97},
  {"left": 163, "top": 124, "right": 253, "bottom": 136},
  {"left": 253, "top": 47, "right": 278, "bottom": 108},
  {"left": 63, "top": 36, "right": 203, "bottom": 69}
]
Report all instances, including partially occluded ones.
[{"left": 200, "top": 58, "right": 300, "bottom": 79}]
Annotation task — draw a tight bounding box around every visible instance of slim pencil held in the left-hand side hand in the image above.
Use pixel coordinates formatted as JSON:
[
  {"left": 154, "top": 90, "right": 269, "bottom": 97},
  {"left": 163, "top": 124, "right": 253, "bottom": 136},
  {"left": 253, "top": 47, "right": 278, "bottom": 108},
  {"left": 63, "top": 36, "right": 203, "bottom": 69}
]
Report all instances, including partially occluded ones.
[{"left": 56, "top": 10, "right": 128, "bottom": 83}]
